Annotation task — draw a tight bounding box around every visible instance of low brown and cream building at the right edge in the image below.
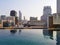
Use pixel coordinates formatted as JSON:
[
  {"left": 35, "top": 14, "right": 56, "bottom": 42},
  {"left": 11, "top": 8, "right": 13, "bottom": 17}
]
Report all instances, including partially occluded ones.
[{"left": 47, "top": 13, "right": 60, "bottom": 28}]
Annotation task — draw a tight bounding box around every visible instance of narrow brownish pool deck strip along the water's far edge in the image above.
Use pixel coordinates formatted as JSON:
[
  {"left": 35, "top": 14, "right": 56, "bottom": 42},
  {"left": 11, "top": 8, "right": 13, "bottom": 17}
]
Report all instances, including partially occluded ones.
[{"left": 0, "top": 26, "right": 60, "bottom": 30}]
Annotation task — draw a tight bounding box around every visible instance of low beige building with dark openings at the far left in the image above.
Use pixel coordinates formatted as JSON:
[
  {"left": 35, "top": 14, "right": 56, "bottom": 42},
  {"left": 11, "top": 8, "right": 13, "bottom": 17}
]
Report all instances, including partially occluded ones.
[{"left": 0, "top": 16, "right": 15, "bottom": 27}]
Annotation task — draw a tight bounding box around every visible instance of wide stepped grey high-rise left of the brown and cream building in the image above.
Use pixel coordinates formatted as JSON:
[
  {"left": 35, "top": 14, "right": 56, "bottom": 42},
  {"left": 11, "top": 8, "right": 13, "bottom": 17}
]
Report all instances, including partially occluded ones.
[{"left": 41, "top": 6, "right": 51, "bottom": 25}]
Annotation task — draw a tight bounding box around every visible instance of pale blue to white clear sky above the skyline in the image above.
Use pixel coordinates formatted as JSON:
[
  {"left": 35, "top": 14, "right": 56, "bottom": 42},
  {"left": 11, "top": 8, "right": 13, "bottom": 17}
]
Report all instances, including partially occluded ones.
[{"left": 0, "top": 0, "right": 56, "bottom": 20}]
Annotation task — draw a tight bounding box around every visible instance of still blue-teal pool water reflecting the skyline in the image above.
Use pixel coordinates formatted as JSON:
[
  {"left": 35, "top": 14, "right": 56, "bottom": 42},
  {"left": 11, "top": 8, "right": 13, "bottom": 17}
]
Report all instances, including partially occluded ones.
[{"left": 0, "top": 29, "right": 60, "bottom": 45}]
